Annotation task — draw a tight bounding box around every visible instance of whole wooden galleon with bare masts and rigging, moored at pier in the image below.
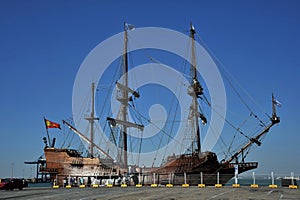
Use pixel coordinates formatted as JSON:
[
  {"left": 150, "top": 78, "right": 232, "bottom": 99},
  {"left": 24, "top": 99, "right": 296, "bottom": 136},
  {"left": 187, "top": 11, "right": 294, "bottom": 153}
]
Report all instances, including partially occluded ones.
[{"left": 40, "top": 23, "right": 280, "bottom": 185}]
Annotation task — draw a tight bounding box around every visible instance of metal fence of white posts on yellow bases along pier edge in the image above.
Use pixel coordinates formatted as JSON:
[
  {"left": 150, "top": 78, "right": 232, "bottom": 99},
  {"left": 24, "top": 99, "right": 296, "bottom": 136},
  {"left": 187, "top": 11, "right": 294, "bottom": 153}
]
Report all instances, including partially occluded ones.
[{"left": 53, "top": 172, "right": 300, "bottom": 187}]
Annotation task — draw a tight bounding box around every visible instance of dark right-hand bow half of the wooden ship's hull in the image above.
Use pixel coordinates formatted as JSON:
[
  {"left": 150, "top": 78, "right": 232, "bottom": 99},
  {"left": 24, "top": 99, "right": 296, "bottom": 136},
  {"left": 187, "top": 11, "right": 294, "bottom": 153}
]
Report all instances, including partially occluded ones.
[{"left": 142, "top": 152, "right": 258, "bottom": 185}]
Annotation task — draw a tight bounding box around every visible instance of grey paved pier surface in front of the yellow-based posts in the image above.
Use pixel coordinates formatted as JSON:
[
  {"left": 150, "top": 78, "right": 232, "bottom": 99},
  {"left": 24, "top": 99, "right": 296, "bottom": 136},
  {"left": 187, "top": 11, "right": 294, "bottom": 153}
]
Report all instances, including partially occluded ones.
[{"left": 0, "top": 186, "right": 300, "bottom": 200}]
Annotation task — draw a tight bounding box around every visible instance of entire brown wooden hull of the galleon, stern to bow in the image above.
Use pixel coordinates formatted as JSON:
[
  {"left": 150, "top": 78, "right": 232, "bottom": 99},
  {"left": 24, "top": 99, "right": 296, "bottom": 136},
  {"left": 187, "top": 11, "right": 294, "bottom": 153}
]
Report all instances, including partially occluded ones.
[{"left": 40, "top": 147, "right": 258, "bottom": 185}]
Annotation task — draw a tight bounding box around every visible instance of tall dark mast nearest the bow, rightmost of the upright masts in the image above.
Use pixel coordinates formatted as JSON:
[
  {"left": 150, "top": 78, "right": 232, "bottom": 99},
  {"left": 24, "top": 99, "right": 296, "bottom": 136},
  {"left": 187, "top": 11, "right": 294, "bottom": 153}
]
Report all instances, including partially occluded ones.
[{"left": 190, "top": 23, "right": 203, "bottom": 154}]
